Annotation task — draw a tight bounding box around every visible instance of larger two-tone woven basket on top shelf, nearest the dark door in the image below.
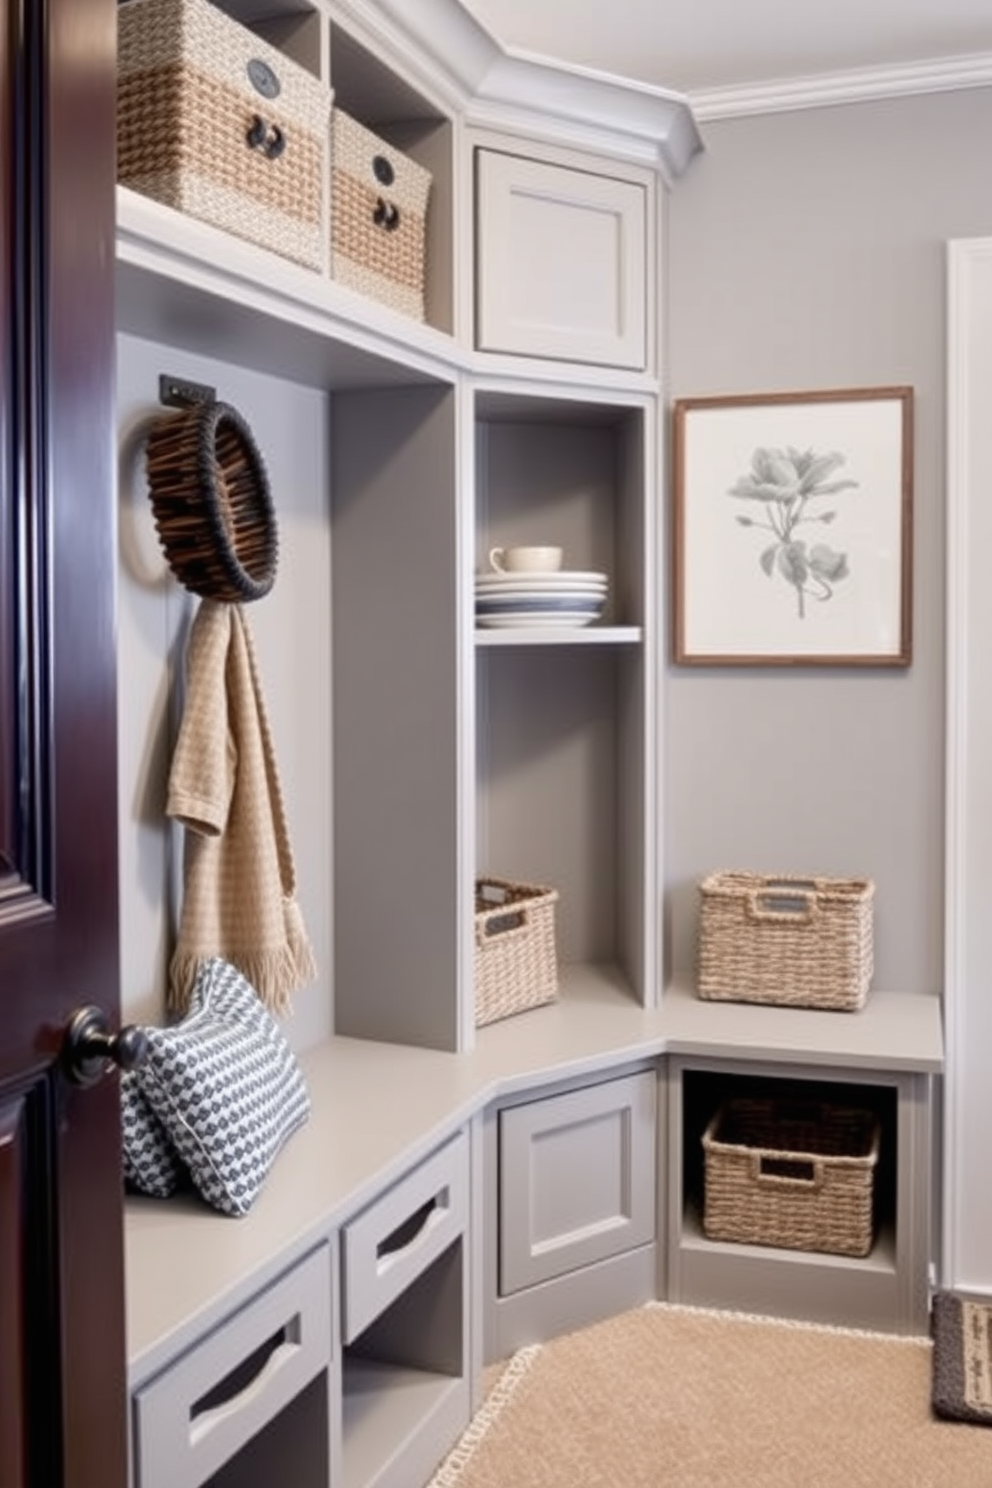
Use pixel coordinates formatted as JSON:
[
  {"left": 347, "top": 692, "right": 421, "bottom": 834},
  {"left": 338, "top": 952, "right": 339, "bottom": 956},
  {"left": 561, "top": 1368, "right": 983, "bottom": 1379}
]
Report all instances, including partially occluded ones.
[{"left": 117, "top": 0, "right": 332, "bottom": 272}]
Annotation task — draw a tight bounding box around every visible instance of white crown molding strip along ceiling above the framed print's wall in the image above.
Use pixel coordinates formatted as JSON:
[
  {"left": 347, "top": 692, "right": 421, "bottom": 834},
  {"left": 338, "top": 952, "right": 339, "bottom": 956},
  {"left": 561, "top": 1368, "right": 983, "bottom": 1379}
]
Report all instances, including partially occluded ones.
[{"left": 687, "top": 52, "right": 992, "bottom": 122}]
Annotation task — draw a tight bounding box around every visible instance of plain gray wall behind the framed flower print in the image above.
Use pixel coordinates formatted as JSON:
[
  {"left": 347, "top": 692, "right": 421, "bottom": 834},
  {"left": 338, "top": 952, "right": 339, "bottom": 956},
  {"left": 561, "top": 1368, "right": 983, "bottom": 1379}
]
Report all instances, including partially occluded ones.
[{"left": 662, "top": 78, "right": 992, "bottom": 991}]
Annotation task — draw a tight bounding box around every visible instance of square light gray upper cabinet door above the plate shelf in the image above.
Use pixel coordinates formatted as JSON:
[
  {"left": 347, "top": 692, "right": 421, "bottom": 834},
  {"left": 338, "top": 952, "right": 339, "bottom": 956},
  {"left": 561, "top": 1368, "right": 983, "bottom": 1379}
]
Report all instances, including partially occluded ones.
[{"left": 476, "top": 150, "right": 647, "bottom": 371}]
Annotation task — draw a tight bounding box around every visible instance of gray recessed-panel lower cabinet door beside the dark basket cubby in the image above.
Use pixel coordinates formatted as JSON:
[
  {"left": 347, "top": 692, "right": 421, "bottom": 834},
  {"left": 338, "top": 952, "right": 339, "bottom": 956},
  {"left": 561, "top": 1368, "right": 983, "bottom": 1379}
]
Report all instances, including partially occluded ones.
[{"left": 500, "top": 1070, "right": 657, "bottom": 1296}]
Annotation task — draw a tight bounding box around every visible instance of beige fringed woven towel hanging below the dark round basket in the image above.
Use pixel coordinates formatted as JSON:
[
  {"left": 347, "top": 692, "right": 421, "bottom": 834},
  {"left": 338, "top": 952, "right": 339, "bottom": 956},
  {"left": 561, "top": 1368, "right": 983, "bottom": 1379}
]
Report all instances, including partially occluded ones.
[{"left": 167, "top": 600, "right": 317, "bottom": 1013}]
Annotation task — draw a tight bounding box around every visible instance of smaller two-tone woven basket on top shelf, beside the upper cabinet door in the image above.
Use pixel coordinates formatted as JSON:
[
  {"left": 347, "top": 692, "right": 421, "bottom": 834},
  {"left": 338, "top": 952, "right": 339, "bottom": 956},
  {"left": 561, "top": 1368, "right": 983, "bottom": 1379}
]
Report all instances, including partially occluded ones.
[{"left": 330, "top": 109, "right": 431, "bottom": 320}]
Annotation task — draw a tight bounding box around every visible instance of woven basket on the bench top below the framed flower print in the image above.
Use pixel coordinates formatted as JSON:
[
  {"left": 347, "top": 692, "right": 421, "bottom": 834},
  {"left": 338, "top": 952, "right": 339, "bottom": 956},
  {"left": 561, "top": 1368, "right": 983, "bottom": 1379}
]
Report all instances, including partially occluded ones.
[{"left": 696, "top": 873, "right": 875, "bottom": 1012}]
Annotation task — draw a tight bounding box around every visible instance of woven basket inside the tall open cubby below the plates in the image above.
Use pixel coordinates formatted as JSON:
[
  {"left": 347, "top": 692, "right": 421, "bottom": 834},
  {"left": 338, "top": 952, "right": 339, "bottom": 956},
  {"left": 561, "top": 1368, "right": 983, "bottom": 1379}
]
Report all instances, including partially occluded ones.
[{"left": 476, "top": 878, "right": 558, "bottom": 1028}]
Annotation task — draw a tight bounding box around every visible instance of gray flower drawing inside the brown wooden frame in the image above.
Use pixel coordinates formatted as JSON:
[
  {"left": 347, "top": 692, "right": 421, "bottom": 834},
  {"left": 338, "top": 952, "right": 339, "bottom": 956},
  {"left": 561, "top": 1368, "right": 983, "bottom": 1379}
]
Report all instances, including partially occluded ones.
[{"left": 727, "top": 445, "right": 858, "bottom": 619}]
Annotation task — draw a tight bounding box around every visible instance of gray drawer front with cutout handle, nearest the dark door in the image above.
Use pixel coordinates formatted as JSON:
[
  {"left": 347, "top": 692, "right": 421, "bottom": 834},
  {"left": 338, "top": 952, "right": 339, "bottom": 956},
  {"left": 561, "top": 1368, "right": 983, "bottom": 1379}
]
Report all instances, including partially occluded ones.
[{"left": 131, "top": 1245, "right": 332, "bottom": 1488}]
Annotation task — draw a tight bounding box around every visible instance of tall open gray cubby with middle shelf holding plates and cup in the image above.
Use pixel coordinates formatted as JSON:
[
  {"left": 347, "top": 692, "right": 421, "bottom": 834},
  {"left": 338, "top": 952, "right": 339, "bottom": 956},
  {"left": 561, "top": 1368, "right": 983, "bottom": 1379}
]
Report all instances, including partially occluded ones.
[{"left": 474, "top": 388, "right": 657, "bottom": 1004}]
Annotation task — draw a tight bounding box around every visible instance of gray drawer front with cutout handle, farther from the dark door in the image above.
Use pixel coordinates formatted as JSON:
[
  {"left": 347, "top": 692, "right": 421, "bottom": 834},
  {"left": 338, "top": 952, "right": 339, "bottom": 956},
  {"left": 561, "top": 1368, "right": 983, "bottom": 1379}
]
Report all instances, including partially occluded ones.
[{"left": 341, "top": 1132, "right": 468, "bottom": 1344}]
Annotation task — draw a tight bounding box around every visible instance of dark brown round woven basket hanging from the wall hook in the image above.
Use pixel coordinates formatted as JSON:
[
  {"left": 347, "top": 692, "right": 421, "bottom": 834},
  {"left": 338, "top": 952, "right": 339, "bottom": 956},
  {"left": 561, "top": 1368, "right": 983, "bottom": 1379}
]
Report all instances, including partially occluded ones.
[{"left": 146, "top": 402, "right": 278, "bottom": 604}]
